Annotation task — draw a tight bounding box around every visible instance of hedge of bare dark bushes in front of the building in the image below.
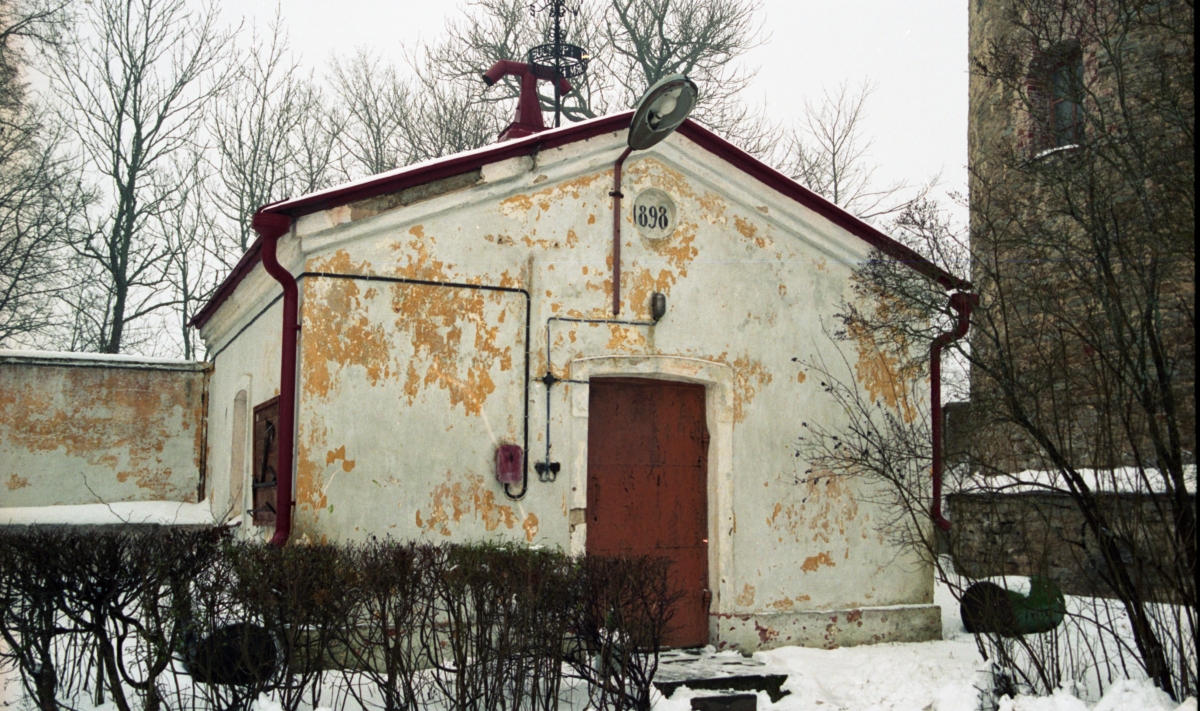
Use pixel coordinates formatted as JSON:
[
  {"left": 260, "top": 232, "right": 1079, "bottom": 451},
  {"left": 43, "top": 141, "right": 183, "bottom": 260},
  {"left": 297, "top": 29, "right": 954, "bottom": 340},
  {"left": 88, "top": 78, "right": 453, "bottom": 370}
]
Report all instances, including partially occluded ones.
[{"left": 0, "top": 528, "right": 678, "bottom": 711}]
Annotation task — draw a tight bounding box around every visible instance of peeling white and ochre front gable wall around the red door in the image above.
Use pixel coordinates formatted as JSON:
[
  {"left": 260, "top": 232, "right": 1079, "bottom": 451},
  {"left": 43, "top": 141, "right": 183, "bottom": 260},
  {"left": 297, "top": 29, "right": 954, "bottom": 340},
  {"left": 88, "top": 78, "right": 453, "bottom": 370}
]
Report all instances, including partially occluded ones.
[{"left": 201, "top": 133, "right": 938, "bottom": 649}]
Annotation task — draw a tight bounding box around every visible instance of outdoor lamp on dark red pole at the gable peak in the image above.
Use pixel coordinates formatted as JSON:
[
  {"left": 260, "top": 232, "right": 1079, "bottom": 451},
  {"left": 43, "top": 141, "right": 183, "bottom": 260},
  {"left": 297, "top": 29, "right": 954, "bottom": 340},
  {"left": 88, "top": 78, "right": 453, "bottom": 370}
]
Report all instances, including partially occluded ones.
[{"left": 611, "top": 74, "right": 698, "bottom": 316}]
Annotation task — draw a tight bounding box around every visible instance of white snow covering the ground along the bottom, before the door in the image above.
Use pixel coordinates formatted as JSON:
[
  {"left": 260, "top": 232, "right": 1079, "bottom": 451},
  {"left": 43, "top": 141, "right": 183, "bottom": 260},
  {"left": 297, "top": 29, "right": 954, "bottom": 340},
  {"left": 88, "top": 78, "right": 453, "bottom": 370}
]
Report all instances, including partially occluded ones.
[{"left": 0, "top": 569, "right": 1198, "bottom": 711}]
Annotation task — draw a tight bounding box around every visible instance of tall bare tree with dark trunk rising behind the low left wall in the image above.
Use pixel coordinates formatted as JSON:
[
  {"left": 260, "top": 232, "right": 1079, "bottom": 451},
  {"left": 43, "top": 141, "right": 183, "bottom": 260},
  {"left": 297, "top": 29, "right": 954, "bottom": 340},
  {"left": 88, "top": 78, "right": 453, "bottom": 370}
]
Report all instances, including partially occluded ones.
[{"left": 48, "top": 0, "right": 232, "bottom": 353}]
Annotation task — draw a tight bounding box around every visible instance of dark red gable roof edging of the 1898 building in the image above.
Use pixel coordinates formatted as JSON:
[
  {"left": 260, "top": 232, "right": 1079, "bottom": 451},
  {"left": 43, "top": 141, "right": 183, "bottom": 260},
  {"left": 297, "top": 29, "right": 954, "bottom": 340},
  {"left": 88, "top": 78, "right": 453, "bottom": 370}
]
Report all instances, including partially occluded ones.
[{"left": 188, "top": 110, "right": 971, "bottom": 328}]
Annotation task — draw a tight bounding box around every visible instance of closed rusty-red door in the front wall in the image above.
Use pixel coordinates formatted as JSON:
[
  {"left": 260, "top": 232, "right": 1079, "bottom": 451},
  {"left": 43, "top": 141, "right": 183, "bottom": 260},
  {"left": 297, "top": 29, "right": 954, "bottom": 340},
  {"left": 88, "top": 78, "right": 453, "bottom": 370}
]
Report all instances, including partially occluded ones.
[{"left": 587, "top": 378, "right": 709, "bottom": 647}]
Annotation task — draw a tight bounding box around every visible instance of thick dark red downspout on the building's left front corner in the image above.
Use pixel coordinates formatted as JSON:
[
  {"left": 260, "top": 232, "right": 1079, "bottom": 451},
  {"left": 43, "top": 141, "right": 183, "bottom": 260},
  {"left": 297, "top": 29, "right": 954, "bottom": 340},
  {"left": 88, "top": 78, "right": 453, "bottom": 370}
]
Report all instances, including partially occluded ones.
[{"left": 250, "top": 213, "right": 300, "bottom": 548}]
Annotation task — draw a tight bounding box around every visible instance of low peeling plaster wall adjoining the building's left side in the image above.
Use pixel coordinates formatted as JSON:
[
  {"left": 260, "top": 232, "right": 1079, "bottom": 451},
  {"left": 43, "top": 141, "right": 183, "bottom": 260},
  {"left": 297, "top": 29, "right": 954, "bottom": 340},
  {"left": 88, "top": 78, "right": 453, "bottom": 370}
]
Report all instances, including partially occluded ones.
[{"left": 0, "top": 351, "right": 209, "bottom": 507}]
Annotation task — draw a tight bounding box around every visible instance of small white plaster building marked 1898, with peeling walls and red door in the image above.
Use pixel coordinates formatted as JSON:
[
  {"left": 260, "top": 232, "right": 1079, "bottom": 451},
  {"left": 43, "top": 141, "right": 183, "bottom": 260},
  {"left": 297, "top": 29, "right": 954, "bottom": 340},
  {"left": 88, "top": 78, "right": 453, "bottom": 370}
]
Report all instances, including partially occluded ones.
[{"left": 189, "top": 113, "right": 964, "bottom": 650}]
